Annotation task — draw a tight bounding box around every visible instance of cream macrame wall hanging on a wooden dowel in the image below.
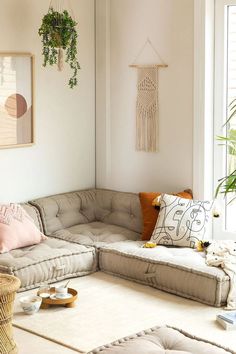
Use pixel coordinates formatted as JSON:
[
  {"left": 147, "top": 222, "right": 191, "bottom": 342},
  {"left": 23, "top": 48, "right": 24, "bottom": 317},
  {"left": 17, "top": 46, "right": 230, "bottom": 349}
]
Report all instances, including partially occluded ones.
[{"left": 129, "top": 38, "right": 168, "bottom": 152}]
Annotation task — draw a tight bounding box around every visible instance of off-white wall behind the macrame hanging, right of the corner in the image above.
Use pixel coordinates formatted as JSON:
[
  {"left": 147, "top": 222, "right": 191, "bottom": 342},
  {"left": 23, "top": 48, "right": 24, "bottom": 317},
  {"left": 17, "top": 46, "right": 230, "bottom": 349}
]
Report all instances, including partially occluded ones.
[{"left": 96, "top": 0, "right": 193, "bottom": 192}]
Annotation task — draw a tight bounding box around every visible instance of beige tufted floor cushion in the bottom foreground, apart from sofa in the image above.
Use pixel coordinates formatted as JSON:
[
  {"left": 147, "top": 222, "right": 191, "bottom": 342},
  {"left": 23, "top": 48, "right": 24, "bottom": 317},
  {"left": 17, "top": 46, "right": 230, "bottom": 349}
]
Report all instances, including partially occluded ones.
[{"left": 88, "top": 327, "right": 233, "bottom": 354}]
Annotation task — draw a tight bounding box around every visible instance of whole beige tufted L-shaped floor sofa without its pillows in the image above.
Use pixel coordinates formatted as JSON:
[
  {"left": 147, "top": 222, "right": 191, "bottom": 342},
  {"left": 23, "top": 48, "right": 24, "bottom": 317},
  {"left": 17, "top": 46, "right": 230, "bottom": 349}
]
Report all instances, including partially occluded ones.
[{"left": 0, "top": 189, "right": 230, "bottom": 307}]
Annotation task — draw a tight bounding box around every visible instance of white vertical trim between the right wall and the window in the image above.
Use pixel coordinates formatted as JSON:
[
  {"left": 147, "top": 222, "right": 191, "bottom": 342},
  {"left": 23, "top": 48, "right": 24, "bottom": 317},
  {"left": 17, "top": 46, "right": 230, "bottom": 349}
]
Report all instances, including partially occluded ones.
[{"left": 193, "top": 0, "right": 215, "bottom": 199}]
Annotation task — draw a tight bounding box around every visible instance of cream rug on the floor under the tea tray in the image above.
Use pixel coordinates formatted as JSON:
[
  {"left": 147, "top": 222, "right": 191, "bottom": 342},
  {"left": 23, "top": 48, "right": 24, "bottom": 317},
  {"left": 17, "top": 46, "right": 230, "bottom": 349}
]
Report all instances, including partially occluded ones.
[{"left": 13, "top": 272, "right": 236, "bottom": 352}]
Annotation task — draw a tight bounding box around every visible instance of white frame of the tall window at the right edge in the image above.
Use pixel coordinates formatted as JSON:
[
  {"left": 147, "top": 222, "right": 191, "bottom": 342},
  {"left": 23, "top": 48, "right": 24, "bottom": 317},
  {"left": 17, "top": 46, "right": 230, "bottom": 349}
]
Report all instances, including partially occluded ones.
[{"left": 213, "top": 0, "right": 236, "bottom": 239}]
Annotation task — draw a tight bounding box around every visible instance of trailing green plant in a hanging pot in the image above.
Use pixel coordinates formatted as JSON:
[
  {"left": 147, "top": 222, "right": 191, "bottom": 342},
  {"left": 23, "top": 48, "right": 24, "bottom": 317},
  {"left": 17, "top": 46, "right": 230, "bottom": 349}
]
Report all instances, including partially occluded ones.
[{"left": 39, "top": 7, "right": 80, "bottom": 88}]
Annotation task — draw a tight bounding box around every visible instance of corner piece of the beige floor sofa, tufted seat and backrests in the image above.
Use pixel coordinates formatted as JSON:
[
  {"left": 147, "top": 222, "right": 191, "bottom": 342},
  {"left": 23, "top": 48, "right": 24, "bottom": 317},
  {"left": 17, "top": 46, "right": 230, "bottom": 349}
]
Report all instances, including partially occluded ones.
[{"left": 30, "top": 189, "right": 142, "bottom": 247}]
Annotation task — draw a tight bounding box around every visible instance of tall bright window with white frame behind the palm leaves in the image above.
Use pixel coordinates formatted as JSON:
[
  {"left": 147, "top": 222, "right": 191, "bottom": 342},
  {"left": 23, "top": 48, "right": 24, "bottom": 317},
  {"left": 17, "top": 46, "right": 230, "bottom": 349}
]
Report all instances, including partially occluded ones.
[{"left": 214, "top": 0, "right": 236, "bottom": 239}]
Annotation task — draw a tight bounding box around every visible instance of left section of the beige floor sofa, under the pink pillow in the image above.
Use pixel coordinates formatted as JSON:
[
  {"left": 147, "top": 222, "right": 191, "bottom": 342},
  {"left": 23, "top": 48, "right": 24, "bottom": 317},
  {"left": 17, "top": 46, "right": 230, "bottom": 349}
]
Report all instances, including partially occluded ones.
[{"left": 0, "top": 204, "right": 97, "bottom": 291}]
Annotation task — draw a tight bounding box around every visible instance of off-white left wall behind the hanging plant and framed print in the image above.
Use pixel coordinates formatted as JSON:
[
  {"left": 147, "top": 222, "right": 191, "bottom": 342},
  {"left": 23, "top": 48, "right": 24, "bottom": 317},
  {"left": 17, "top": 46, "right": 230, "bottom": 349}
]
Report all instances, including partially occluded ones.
[{"left": 0, "top": 0, "right": 95, "bottom": 202}]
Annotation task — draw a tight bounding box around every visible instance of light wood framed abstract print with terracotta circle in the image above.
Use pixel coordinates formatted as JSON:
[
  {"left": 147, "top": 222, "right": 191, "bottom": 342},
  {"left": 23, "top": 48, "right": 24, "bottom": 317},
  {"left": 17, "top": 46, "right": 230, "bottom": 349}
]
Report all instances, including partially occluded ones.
[{"left": 0, "top": 52, "right": 34, "bottom": 148}]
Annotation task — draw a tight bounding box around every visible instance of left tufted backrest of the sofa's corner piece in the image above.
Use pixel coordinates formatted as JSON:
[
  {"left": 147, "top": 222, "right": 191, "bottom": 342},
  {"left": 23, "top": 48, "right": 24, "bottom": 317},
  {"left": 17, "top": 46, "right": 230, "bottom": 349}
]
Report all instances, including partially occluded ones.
[{"left": 30, "top": 189, "right": 96, "bottom": 235}]
